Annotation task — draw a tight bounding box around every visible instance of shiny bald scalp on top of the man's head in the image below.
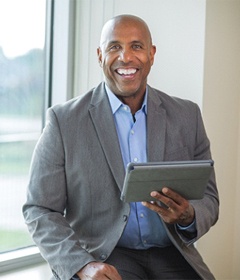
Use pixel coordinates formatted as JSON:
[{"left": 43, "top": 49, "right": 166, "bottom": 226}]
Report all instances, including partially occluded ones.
[{"left": 100, "top": 15, "right": 152, "bottom": 47}]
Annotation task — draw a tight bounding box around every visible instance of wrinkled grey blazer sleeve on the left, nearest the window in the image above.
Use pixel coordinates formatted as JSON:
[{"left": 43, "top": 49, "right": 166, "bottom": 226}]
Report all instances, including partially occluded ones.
[{"left": 23, "top": 109, "right": 95, "bottom": 280}]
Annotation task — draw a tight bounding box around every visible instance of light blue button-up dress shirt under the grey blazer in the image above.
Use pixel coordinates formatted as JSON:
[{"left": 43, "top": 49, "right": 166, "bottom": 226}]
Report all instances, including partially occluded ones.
[{"left": 106, "top": 86, "right": 171, "bottom": 249}]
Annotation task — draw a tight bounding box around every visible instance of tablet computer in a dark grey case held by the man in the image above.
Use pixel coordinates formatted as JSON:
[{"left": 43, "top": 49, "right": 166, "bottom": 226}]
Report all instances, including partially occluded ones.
[{"left": 121, "top": 160, "right": 214, "bottom": 202}]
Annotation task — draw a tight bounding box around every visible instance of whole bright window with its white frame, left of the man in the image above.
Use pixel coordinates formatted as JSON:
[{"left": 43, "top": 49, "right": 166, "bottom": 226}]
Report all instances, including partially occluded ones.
[{"left": 0, "top": 0, "right": 77, "bottom": 272}]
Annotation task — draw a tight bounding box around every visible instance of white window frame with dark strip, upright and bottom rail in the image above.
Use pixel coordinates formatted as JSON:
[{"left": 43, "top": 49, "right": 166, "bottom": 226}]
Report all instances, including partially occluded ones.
[{"left": 0, "top": 0, "right": 76, "bottom": 275}]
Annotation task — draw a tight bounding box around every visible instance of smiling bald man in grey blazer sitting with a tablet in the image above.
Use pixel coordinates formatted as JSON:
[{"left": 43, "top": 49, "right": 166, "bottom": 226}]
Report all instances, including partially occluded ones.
[{"left": 23, "top": 15, "right": 219, "bottom": 280}]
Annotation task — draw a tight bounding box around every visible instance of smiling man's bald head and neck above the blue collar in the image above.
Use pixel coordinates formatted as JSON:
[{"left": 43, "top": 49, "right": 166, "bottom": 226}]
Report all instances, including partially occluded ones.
[{"left": 98, "top": 16, "right": 156, "bottom": 106}]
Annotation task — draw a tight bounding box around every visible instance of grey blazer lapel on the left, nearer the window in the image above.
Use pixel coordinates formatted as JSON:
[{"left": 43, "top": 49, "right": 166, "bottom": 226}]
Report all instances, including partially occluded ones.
[{"left": 89, "top": 83, "right": 125, "bottom": 190}]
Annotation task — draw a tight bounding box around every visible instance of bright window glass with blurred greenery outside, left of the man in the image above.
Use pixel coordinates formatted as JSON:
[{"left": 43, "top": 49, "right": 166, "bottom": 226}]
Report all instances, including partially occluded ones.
[{"left": 0, "top": 0, "right": 46, "bottom": 252}]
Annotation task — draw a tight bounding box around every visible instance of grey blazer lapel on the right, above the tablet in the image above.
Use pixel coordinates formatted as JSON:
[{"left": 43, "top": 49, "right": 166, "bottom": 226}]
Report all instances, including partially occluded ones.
[{"left": 147, "top": 87, "right": 166, "bottom": 162}]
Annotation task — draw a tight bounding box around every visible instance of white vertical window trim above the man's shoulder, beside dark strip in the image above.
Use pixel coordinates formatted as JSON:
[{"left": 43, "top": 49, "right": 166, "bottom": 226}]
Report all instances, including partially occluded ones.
[{"left": 50, "top": 0, "right": 76, "bottom": 105}]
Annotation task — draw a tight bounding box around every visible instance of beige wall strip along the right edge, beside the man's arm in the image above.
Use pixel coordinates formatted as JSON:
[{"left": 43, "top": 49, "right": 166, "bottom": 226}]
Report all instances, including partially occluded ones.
[{"left": 198, "top": 0, "right": 240, "bottom": 280}]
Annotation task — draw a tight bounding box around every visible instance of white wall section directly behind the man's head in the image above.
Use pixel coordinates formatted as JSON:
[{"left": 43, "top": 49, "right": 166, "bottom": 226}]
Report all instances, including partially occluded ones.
[{"left": 74, "top": 0, "right": 205, "bottom": 106}]
